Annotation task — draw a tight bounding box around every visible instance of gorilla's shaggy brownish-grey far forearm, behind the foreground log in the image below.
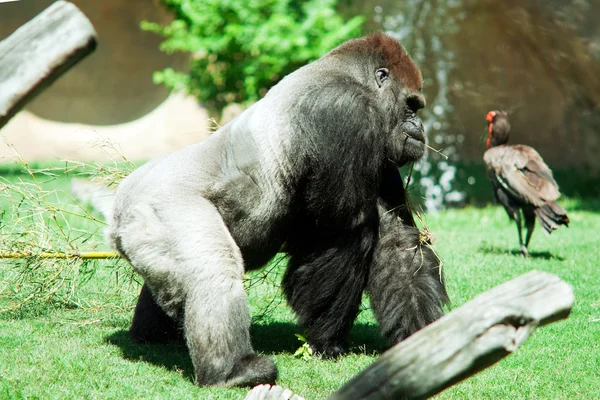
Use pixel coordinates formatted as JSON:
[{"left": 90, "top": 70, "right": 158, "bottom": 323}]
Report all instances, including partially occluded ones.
[{"left": 367, "top": 209, "right": 448, "bottom": 344}]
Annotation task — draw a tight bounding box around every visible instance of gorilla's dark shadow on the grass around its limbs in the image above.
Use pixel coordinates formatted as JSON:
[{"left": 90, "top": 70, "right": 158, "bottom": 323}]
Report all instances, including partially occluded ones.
[{"left": 105, "top": 322, "right": 387, "bottom": 376}]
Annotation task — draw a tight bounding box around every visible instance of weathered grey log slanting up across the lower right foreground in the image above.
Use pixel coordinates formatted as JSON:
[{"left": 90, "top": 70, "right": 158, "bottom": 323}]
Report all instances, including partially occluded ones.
[{"left": 330, "top": 271, "right": 574, "bottom": 400}]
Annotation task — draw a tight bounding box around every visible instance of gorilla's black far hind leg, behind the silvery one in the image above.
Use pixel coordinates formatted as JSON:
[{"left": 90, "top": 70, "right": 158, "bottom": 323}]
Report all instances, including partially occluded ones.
[{"left": 129, "top": 284, "right": 183, "bottom": 343}]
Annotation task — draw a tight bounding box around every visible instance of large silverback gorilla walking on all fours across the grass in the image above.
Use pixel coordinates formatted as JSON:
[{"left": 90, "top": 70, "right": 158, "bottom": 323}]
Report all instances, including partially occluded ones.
[{"left": 109, "top": 33, "right": 447, "bottom": 386}]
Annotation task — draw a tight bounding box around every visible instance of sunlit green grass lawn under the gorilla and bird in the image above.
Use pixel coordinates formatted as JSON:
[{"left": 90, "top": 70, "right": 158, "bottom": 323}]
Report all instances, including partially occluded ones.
[{"left": 0, "top": 170, "right": 600, "bottom": 400}]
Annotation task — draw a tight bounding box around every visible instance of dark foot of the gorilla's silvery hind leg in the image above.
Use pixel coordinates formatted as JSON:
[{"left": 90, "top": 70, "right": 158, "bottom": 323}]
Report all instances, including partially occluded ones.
[{"left": 225, "top": 354, "right": 277, "bottom": 386}]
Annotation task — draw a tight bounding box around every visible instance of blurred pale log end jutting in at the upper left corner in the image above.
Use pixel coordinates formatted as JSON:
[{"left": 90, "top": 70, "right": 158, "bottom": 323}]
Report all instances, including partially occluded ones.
[{"left": 0, "top": 1, "right": 96, "bottom": 128}]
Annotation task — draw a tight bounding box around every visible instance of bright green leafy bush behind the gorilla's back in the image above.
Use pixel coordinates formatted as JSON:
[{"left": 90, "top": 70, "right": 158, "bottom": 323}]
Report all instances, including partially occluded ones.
[{"left": 141, "top": 0, "right": 363, "bottom": 111}]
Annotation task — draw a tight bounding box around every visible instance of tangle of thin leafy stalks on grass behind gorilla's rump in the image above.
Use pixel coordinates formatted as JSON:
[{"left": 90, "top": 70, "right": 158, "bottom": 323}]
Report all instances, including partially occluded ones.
[{"left": 0, "top": 138, "right": 133, "bottom": 312}]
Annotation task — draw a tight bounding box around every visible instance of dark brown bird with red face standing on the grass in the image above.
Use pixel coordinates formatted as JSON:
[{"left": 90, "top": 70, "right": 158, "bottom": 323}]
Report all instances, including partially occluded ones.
[{"left": 483, "top": 110, "right": 569, "bottom": 257}]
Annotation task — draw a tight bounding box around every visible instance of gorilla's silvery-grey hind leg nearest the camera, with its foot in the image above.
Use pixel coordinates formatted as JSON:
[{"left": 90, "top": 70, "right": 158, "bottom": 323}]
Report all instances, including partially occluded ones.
[{"left": 117, "top": 198, "right": 277, "bottom": 386}]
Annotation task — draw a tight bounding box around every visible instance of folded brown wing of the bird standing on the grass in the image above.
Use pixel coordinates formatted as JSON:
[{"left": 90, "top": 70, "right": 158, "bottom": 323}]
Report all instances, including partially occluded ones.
[{"left": 483, "top": 145, "right": 560, "bottom": 207}]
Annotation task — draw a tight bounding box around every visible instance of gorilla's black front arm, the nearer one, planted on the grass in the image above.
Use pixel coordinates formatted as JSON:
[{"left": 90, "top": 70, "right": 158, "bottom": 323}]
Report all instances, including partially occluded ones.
[{"left": 283, "top": 231, "right": 374, "bottom": 357}]
